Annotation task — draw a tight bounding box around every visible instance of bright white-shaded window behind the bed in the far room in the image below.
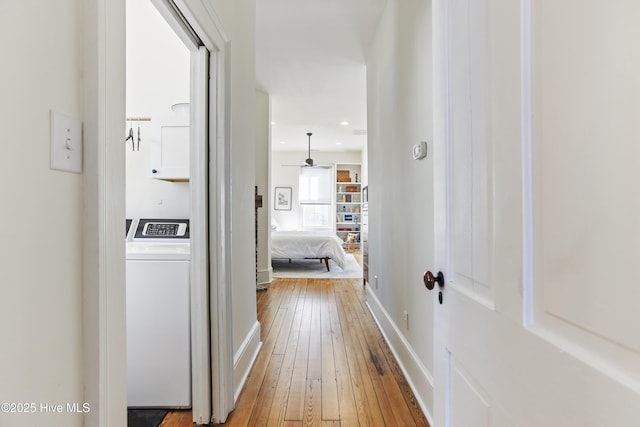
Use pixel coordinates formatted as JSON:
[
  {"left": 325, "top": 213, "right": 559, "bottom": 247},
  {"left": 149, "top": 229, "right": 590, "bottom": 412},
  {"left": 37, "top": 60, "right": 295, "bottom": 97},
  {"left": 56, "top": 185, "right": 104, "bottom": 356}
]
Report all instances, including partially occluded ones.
[{"left": 298, "top": 167, "right": 333, "bottom": 228}]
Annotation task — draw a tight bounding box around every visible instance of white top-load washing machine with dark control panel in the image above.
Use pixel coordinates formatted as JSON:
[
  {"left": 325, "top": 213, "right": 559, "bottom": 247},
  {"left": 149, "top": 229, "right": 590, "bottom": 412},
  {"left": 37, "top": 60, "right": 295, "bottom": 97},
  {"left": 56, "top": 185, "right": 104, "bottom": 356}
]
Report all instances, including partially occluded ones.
[{"left": 126, "top": 219, "right": 191, "bottom": 408}]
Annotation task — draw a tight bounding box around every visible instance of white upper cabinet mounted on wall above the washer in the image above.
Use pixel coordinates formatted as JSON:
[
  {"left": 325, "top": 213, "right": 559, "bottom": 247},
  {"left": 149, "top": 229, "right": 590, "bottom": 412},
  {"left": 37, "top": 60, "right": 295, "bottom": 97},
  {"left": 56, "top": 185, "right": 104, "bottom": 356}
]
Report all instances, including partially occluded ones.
[{"left": 151, "top": 126, "right": 189, "bottom": 181}]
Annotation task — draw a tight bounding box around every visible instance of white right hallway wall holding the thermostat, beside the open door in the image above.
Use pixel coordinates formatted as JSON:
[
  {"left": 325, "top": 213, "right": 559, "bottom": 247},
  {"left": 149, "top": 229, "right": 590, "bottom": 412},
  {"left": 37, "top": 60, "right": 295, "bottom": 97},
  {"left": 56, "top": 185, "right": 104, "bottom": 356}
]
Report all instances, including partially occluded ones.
[{"left": 367, "top": 0, "right": 434, "bottom": 418}]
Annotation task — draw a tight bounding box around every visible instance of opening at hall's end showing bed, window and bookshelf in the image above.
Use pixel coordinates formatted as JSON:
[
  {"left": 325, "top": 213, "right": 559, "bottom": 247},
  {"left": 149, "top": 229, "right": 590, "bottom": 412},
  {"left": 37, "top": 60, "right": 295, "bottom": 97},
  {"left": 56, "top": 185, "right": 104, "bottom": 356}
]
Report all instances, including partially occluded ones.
[{"left": 269, "top": 145, "right": 366, "bottom": 277}]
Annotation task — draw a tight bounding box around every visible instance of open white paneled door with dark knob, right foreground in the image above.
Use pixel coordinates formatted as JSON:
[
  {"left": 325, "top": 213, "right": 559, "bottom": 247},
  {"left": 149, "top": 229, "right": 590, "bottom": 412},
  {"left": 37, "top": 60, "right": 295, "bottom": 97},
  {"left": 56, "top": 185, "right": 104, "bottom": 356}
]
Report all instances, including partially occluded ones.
[{"left": 432, "top": 0, "right": 640, "bottom": 427}]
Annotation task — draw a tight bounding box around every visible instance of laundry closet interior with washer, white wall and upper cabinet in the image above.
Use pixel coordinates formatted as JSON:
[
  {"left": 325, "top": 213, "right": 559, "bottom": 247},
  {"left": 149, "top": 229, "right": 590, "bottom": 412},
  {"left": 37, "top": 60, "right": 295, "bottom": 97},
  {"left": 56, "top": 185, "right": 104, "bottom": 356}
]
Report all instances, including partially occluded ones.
[{"left": 123, "top": 0, "right": 192, "bottom": 408}]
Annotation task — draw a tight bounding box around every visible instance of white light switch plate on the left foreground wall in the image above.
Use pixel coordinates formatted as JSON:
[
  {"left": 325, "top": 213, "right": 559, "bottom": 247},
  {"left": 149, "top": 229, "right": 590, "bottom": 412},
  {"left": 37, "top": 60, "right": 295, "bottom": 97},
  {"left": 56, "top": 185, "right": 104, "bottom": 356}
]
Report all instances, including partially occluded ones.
[{"left": 49, "top": 110, "right": 82, "bottom": 173}]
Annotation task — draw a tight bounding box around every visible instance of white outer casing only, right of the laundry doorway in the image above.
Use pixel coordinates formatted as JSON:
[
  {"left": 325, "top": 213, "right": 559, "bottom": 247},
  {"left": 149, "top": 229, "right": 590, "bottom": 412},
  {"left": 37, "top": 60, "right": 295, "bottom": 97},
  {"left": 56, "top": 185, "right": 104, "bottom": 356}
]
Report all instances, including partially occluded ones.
[{"left": 175, "top": 0, "right": 234, "bottom": 423}]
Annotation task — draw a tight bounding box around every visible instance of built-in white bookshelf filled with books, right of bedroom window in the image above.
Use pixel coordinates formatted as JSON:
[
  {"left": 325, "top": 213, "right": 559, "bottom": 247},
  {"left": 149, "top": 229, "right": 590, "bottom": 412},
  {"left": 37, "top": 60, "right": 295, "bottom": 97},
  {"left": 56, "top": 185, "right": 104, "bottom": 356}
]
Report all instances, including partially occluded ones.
[{"left": 336, "top": 163, "right": 362, "bottom": 246}]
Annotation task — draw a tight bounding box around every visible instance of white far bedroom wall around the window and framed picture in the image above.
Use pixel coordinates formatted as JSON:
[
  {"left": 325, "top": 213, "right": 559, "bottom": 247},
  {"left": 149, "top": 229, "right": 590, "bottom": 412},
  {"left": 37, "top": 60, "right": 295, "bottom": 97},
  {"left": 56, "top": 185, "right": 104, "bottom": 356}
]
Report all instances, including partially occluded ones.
[{"left": 269, "top": 151, "right": 362, "bottom": 230}]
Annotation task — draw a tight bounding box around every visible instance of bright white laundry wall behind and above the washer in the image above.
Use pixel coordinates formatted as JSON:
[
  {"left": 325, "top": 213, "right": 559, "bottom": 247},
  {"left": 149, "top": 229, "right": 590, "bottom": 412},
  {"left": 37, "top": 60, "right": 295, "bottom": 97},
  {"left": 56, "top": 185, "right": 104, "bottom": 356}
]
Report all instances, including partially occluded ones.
[{"left": 123, "top": 0, "right": 190, "bottom": 218}]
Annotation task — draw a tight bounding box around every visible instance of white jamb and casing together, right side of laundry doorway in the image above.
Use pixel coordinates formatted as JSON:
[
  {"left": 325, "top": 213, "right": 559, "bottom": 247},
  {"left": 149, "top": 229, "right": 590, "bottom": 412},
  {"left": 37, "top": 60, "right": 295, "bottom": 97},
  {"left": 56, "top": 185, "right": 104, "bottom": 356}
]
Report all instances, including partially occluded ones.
[{"left": 152, "top": 0, "right": 234, "bottom": 425}]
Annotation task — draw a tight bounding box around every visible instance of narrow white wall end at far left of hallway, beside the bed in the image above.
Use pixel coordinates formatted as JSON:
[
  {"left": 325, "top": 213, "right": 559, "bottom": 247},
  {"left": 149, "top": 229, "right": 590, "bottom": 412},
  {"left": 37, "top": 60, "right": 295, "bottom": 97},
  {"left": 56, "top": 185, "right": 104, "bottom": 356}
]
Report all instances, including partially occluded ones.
[{"left": 256, "top": 90, "right": 273, "bottom": 284}]
